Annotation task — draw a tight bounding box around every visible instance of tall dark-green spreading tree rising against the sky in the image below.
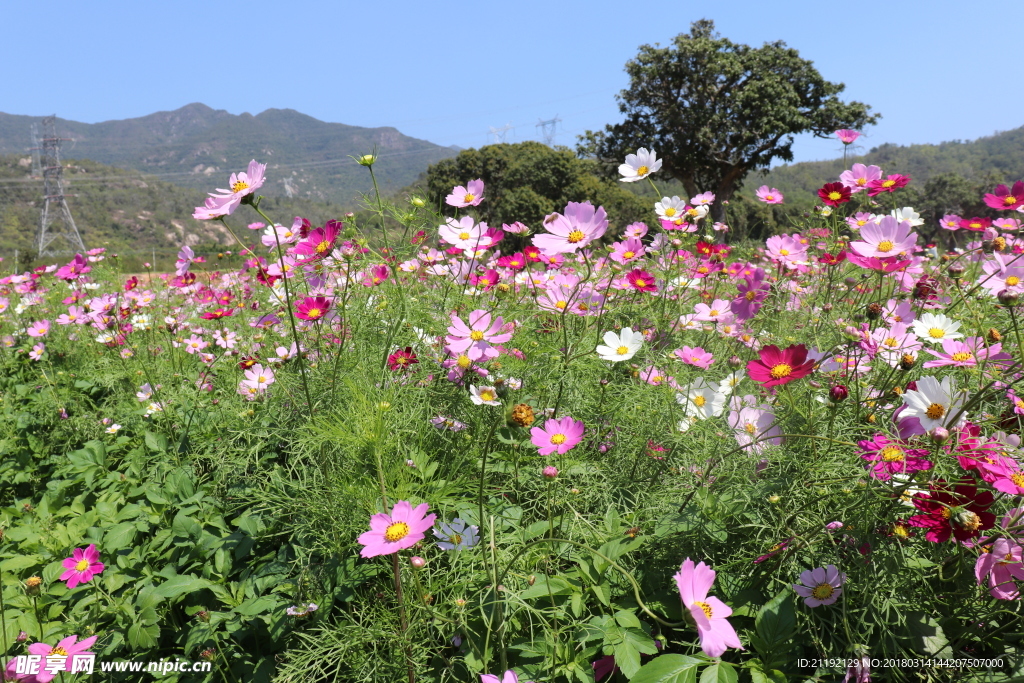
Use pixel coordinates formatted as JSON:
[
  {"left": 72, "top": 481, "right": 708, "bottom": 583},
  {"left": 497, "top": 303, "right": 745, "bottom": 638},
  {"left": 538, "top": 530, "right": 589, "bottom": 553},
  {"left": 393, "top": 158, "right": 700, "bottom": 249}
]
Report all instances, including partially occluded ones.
[{"left": 579, "top": 19, "right": 879, "bottom": 219}]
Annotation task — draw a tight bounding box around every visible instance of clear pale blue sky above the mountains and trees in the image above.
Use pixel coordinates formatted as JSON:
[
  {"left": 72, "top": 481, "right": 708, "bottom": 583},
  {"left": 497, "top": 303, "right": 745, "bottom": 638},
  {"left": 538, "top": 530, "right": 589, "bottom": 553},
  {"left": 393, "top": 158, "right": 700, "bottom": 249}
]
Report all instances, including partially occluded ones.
[{"left": 0, "top": 0, "right": 1024, "bottom": 161}]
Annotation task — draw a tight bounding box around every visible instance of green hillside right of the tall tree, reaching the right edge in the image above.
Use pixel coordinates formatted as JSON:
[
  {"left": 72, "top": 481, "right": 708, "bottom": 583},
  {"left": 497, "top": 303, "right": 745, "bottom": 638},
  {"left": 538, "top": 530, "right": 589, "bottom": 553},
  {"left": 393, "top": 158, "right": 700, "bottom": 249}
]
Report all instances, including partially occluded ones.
[{"left": 743, "top": 127, "right": 1024, "bottom": 204}]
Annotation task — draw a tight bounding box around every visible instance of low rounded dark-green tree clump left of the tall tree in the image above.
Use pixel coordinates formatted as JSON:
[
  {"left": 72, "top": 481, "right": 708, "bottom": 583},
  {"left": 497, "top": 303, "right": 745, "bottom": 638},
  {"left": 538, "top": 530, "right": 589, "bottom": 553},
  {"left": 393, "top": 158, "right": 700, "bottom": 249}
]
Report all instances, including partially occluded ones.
[{"left": 427, "top": 141, "right": 654, "bottom": 230}]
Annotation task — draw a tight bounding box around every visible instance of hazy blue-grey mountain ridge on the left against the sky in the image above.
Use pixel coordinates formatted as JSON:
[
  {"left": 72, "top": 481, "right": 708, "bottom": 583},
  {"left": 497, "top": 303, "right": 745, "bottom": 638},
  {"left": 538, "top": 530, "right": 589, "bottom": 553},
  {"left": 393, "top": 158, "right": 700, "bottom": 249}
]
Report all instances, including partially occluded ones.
[{"left": 0, "top": 103, "right": 458, "bottom": 206}]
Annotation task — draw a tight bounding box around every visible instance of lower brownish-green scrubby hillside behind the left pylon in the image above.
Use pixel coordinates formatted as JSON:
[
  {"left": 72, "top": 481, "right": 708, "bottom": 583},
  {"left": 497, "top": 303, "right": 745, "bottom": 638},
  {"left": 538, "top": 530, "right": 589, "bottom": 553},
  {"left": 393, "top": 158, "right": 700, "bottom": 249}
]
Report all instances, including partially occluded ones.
[{"left": 0, "top": 155, "right": 348, "bottom": 271}]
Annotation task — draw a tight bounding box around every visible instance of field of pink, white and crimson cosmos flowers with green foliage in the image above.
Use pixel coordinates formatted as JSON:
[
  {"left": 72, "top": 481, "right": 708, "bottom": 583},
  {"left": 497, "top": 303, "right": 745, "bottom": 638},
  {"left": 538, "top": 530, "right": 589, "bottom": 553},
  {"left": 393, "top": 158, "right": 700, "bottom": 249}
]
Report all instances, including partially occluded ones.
[{"left": 0, "top": 145, "right": 1024, "bottom": 683}]
